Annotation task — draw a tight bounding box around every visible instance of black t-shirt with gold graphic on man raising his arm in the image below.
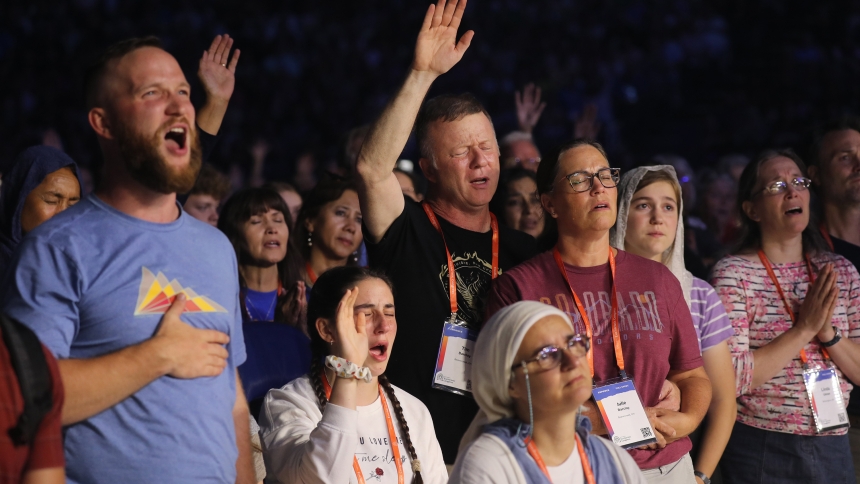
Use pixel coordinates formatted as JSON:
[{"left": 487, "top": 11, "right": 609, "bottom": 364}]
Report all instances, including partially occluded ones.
[{"left": 365, "top": 198, "right": 537, "bottom": 464}]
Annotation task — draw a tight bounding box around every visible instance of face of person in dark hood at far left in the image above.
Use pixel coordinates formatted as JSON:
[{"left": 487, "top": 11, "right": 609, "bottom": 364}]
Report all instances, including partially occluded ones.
[{"left": 21, "top": 167, "right": 81, "bottom": 235}]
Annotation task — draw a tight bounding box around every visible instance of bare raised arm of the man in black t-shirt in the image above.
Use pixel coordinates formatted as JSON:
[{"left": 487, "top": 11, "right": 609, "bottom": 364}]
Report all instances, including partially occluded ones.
[{"left": 356, "top": 0, "right": 474, "bottom": 242}]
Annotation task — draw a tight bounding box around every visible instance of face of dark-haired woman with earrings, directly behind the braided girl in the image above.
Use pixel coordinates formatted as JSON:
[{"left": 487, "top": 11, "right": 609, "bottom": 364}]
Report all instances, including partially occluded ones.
[{"left": 307, "top": 190, "right": 363, "bottom": 261}]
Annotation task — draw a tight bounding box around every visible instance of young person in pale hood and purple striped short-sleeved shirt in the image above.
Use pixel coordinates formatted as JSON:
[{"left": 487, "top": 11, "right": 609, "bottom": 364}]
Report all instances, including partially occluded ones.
[{"left": 610, "top": 165, "right": 737, "bottom": 484}]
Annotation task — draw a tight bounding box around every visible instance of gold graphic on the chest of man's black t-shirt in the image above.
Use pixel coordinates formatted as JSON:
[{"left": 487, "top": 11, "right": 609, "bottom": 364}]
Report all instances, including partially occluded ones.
[{"left": 439, "top": 252, "right": 502, "bottom": 326}]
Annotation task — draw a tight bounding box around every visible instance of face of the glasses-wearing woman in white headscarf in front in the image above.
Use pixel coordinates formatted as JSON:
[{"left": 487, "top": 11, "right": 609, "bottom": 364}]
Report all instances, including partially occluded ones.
[{"left": 509, "top": 316, "right": 591, "bottom": 422}]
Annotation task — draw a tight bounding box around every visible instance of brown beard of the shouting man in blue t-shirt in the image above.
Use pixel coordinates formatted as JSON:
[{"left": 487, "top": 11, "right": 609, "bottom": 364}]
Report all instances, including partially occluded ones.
[{"left": 114, "top": 120, "right": 203, "bottom": 194}]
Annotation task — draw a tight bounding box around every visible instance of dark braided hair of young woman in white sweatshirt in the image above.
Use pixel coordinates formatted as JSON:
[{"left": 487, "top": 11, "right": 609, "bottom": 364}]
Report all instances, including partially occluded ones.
[{"left": 308, "top": 266, "right": 424, "bottom": 484}]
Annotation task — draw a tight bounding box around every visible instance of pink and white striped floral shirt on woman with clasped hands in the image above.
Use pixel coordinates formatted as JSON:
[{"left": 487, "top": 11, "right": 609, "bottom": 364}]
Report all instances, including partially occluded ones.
[{"left": 711, "top": 253, "right": 860, "bottom": 435}]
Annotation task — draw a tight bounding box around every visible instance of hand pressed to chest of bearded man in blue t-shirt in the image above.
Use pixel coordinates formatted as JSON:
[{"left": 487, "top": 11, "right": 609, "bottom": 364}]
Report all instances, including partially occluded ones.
[{"left": 152, "top": 294, "right": 230, "bottom": 378}]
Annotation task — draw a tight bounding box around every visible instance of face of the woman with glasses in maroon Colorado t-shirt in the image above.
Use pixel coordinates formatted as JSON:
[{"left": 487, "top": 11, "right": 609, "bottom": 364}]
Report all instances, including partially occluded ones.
[{"left": 541, "top": 145, "right": 618, "bottom": 234}]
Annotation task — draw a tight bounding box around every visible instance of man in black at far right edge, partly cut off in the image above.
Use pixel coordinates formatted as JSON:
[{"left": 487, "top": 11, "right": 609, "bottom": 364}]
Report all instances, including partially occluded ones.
[{"left": 807, "top": 117, "right": 860, "bottom": 481}]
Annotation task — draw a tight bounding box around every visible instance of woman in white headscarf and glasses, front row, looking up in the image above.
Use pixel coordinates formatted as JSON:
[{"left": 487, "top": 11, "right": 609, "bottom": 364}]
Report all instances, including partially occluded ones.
[{"left": 449, "top": 301, "right": 645, "bottom": 484}]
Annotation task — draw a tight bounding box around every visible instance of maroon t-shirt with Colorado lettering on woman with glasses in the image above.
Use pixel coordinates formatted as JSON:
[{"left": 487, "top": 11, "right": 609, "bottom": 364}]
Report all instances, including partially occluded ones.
[{"left": 487, "top": 250, "right": 702, "bottom": 469}]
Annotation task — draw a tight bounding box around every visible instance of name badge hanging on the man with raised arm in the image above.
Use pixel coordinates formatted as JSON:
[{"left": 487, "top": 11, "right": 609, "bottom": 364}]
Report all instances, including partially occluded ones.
[{"left": 433, "top": 314, "right": 478, "bottom": 395}]
